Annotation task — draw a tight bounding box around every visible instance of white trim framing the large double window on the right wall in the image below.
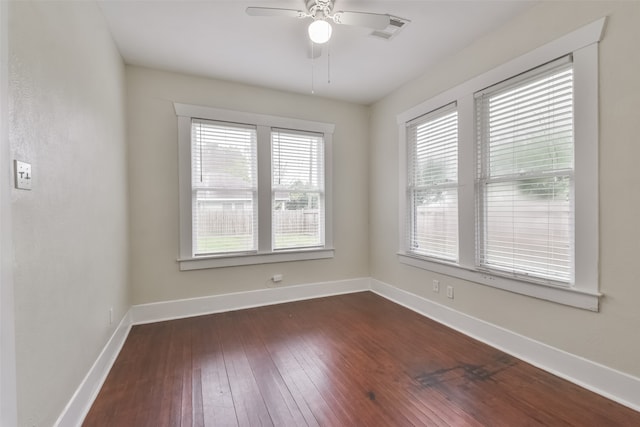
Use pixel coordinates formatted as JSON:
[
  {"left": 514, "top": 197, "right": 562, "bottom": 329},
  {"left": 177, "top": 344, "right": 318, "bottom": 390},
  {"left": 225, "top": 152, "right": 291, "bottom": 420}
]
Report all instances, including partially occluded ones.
[{"left": 397, "top": 17, "right": 606, "bottom": 311}]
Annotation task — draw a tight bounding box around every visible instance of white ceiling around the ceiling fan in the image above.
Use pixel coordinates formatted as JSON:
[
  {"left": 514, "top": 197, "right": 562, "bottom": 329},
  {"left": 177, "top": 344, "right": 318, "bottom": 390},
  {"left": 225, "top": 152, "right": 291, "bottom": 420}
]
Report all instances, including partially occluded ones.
[{"left": 98, "top": 0, "right": 533, "bottom": 104}]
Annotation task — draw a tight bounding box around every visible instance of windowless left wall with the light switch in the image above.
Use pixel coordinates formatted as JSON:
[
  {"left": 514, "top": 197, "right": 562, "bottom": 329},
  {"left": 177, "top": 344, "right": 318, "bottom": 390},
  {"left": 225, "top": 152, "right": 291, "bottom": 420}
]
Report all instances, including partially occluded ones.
[{"left": 8, "top": 1, "right": 130, "bottom": 427}]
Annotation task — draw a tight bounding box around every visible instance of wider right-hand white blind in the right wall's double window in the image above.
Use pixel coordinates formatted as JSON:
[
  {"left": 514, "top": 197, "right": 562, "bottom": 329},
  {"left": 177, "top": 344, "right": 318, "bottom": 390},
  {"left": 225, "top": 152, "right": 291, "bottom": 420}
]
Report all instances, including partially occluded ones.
[{"left": 476, "top": 56, "right": 574, "bottom": 284}]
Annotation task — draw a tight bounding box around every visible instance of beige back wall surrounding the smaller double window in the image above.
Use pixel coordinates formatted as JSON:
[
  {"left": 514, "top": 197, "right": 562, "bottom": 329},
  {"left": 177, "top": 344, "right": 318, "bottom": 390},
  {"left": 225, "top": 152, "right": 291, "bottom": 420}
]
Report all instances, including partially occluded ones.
[{"left": 127, "top": 66, "right": 369, "bottom": 304}]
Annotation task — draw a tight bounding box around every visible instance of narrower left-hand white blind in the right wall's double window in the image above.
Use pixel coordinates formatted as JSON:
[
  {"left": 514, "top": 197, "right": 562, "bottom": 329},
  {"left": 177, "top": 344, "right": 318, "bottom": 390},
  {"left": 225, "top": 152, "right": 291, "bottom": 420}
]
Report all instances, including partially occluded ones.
[{"left": 406, "top": 104, "right": 458, "bottom": 261}]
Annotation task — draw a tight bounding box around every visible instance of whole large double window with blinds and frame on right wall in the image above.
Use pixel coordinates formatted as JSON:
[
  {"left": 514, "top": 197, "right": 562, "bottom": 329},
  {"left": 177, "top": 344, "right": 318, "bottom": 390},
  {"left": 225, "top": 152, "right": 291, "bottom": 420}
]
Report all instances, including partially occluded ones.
[{"left": 398, "top": 18, "right": 605, "bottom": 311}]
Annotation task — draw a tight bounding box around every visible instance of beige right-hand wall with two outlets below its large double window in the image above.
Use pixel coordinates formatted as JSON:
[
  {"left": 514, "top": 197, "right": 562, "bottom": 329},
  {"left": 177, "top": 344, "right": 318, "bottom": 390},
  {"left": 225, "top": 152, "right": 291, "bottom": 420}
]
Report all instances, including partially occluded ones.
[{"left": 369, "top": 2, "right": 640, "bottom": 377}]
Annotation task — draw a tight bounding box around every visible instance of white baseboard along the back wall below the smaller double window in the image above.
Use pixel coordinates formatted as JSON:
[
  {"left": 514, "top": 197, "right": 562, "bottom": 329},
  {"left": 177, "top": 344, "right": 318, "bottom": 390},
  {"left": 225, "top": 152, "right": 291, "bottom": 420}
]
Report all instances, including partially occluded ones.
[{"left": 131, "top": 277, "right": 370, "bottom": 325}]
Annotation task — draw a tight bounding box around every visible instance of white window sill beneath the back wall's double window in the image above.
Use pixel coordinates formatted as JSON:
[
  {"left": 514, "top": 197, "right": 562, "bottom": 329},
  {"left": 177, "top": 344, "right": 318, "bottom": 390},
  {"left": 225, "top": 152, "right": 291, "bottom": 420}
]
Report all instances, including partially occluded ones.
[{"left": 178, "top": 248, "right": 334, "bottom": 271}]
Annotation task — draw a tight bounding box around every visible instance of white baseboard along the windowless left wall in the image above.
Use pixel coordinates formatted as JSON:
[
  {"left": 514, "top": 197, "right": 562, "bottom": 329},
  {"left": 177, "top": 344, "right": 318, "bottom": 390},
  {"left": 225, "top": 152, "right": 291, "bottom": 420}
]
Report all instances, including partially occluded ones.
[{"left": 54, "top": 312, "right": 131, "bottom": 427}]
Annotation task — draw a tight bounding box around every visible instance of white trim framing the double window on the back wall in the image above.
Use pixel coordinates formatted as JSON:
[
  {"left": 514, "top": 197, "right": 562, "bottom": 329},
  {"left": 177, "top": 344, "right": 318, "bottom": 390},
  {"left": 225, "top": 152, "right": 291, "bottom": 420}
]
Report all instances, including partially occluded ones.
[{"left": 173, "top": 103, "right": 335, "bottom": 270}]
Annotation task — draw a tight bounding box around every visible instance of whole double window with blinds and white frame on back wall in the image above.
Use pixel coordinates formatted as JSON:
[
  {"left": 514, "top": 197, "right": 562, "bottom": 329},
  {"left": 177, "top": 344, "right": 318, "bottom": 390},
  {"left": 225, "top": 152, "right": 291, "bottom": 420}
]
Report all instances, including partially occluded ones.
[{"left": 174, "top": 104, "right": 333, "bottom": 270}]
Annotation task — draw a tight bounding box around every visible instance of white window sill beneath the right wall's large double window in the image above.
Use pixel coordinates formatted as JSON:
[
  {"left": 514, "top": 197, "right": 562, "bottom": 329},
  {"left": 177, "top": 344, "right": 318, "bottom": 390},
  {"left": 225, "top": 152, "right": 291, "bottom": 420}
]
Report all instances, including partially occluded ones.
[{"left": 398, "top": 253, "right": 602, "bottom": 312}]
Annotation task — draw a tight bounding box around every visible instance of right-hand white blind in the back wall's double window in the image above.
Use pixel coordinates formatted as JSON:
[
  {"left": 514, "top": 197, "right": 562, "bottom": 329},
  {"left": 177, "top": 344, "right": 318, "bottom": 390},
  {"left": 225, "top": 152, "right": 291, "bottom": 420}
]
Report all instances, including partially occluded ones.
[{"left": 271, "top": 129, "right": 325, "bottom": 249}]
